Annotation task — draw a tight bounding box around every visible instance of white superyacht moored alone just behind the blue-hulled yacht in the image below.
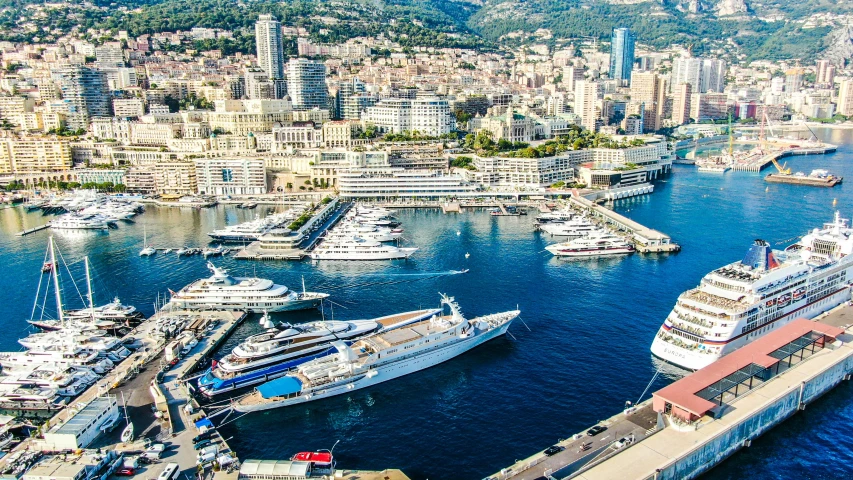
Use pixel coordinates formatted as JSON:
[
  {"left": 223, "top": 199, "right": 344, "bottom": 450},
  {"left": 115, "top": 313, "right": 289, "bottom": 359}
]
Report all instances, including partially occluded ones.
[{"left": 170, "top": 262, "right": 329, "bottom": 312}]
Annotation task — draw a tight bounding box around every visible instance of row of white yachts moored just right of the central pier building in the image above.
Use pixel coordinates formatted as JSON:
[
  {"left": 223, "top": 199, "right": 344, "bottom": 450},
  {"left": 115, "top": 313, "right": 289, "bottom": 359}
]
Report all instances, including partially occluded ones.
[{"left": 309, "top": 205, "right": 418, "bottom": 260}]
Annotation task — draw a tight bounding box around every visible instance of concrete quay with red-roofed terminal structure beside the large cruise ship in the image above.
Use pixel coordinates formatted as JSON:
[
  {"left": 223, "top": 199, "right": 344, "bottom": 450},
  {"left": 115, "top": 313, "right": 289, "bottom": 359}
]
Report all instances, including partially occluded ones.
[{"left": 487, "top": 305, "right": 853, "bottom": 480}]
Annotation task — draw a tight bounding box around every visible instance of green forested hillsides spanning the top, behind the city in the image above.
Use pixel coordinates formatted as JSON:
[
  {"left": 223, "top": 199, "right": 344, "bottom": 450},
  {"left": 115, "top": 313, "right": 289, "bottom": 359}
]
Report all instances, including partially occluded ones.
[{"left": 0, "top": 0, "right": 853, "bottom": 60}]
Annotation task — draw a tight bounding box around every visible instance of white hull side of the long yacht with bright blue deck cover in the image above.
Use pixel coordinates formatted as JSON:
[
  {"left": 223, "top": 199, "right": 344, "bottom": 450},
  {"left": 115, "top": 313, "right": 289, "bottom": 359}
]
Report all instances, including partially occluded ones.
[{"left": 234, "top": 321, "right": 512, "bottom": 413}]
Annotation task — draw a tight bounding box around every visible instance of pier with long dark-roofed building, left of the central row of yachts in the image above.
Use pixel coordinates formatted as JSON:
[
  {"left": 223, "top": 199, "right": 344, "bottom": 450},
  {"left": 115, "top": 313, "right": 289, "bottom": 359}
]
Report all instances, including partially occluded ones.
[{"left": 234, "top": 198, "right": 352, "bottom": 261}]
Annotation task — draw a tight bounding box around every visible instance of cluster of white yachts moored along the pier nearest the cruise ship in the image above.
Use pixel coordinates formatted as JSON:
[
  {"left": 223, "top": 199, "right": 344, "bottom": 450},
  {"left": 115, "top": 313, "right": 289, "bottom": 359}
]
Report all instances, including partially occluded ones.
[{"left": 536, "top": 210, "right": 634, "bottom": 257}]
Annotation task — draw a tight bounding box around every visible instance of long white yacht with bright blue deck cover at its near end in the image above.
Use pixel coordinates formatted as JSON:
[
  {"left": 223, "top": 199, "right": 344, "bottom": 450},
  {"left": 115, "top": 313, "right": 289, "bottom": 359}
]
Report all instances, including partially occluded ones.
[{"left": 232, "top": 295, "right": 520, "bottom": 413}]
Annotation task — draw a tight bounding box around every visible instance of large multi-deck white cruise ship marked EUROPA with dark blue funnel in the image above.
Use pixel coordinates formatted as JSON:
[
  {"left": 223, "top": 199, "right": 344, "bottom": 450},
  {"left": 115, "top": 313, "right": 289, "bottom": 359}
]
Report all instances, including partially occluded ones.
[{"left": 651, "top": 212, "right": 853, "bottom": 370}]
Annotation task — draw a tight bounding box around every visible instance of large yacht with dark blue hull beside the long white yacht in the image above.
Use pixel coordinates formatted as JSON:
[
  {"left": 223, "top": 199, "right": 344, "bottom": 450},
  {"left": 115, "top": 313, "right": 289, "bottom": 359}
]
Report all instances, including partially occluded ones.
[{"left": 198, "top": 309, "right": 440, "bottom": 396}]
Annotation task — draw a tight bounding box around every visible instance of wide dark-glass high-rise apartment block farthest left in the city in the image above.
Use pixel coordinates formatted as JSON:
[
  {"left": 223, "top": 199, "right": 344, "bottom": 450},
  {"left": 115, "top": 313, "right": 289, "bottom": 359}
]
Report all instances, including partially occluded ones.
[{"left": 55, "top": 65, "right": 111, "bottom": 130}]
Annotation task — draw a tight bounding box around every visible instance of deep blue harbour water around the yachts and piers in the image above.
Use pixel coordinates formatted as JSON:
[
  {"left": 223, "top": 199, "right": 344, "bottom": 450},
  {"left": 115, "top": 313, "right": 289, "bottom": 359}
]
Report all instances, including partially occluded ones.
[{"left": 0, "top": 130, "right": 853, "bottom": 479}]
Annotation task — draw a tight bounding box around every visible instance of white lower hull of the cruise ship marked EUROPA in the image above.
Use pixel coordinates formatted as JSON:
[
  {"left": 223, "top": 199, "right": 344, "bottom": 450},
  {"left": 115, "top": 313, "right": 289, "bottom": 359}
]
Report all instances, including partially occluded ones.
[{"left": 652, "top": 287, "right": 850, "bottom": 370}]
